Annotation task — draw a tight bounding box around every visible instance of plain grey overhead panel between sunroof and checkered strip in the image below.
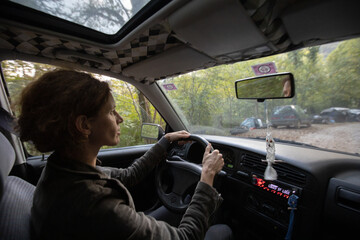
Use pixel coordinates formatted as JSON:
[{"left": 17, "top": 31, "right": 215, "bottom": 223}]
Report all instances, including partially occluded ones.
[{"left": 168, "top": 0, "right": 267, "bottom": 60}]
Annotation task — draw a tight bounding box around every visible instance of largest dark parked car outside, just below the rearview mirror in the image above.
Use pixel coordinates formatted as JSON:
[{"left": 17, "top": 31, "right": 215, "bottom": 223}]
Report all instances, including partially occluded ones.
[{"left": 271, "top": 105, "right": 311, "bottom": 128}]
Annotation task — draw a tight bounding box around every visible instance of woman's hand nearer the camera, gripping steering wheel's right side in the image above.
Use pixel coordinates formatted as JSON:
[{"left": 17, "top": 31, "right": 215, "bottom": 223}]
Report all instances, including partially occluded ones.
[{"left": 200, "top": 143, "right": 224, "bottom": 186}]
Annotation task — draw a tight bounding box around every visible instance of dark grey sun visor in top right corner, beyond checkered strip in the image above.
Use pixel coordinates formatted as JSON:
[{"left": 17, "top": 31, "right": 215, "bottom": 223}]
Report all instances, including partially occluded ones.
[{"left": 281, "top": 0, "right": 360, "bottom": 44}]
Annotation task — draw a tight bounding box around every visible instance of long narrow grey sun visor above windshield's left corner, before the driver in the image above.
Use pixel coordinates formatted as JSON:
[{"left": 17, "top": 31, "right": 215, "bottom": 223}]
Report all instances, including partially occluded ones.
[{"left": 122, "top": 45, "right": 215, "bottom": 82}]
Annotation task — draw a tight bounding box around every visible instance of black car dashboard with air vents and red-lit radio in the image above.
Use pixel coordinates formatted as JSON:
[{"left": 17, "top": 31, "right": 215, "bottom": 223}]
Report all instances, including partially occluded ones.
[{"left": 169, "top": 135, "right": 360, "bottom": 239}]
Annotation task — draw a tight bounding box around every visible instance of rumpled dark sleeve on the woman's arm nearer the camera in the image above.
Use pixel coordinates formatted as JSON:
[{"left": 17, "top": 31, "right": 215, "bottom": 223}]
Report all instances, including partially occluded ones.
[{"left": 89, "top": 182, "right": 221, "bottom": 239}]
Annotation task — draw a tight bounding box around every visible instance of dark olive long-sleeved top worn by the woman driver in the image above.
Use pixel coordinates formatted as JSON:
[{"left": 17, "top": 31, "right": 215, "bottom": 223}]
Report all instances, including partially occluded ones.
[{"left": 31, "top": 138, "right": 221, "bottom": 240}]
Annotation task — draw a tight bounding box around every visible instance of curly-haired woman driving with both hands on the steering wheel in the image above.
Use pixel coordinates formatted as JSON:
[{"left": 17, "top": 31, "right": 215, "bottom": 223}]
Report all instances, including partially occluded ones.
[{"left": 18, "top": 70, "right": 231, "bottom": 239}]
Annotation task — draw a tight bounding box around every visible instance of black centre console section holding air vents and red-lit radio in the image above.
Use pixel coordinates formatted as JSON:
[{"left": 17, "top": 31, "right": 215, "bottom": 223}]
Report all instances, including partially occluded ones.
[{"left": 213, "top": 143, "right": 320, "bottom": 239}]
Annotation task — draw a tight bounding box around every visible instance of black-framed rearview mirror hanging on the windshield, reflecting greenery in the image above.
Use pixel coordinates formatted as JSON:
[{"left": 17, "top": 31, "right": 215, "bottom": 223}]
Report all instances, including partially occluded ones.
[{"left": 235, "top": 73, "right": 295, "bottom": 102}]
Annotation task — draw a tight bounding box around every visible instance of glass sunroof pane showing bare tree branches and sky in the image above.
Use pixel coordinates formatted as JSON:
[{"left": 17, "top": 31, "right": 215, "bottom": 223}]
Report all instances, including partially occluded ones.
[{"left": 11, "top": 0, "right": 150, "bottom": 34}]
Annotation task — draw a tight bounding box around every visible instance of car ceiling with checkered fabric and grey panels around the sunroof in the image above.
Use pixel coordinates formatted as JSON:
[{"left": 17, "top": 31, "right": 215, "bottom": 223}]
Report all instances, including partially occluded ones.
[{"left": 0, "top": 0, "right": 360, "bottom": 84}]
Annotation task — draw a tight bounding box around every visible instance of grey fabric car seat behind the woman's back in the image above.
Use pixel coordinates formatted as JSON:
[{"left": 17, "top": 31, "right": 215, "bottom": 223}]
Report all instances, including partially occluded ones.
[{"left": 0, "top": 111, "right": 35, "bottom": 240}]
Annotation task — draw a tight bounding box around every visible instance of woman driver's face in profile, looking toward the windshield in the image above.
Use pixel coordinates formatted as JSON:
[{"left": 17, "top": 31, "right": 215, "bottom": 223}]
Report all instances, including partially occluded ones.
[{"left": 89, "top": 94, "right": 123, "bottom": 147}]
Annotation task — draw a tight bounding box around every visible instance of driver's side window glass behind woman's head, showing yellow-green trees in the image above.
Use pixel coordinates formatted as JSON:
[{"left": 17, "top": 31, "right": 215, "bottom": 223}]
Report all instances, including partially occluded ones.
[{"left": 1, "top": 61, "right": 165, "bottom": 156}]
